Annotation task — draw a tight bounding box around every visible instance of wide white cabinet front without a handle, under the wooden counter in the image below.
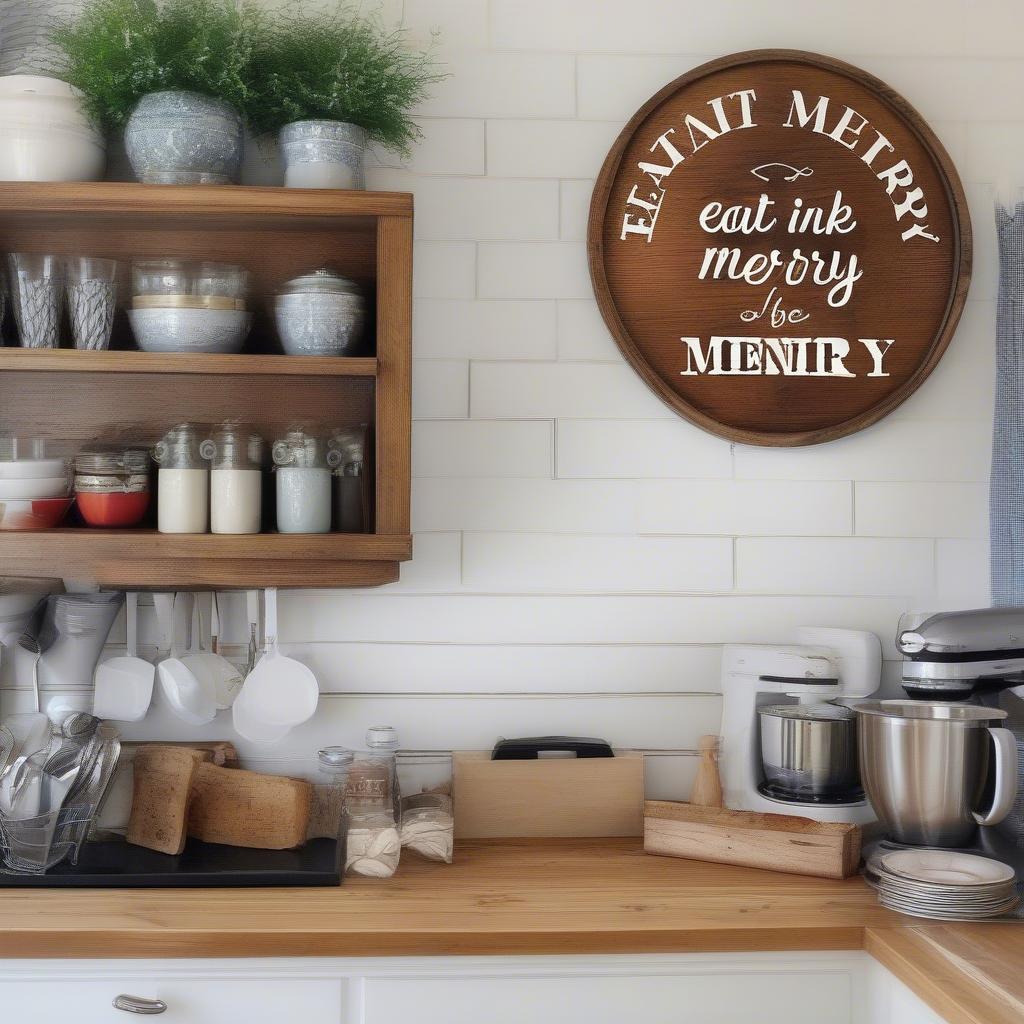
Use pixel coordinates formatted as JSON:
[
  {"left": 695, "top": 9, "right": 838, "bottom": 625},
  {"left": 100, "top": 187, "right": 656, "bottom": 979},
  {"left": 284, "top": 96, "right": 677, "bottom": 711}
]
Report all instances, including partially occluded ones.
[{"left": 364, "top": 971, "right": 852, "bottom": 1024}]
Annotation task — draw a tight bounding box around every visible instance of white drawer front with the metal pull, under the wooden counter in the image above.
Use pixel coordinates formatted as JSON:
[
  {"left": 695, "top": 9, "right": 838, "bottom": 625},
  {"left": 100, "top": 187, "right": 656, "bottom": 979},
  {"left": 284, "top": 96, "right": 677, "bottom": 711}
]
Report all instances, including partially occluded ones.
[{"left": 0, "top": 971, "right": 344, "bottom": 1024}]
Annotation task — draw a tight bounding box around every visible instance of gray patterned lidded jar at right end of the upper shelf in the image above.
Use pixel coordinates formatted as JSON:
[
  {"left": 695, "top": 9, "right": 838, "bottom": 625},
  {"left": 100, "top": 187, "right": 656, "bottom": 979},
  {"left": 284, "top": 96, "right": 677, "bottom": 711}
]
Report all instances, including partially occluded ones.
[{"left": 274, "top": 266, "right": 366, "bottom": 355}]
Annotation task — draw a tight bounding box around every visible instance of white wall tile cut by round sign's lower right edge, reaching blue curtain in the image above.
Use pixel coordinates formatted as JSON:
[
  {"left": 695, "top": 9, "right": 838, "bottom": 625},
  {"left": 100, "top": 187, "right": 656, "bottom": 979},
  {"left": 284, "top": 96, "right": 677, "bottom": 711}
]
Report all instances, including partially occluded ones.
[{"left": 735, "top": 417, "right": 992, "bottom": 481}]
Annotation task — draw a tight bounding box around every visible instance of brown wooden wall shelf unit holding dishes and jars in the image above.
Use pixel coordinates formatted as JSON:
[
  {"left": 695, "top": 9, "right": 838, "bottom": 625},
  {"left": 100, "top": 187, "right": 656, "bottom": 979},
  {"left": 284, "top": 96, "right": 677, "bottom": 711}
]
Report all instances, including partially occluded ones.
[{"left": 0, "top": 182, "right": 413, "bottom": 590}]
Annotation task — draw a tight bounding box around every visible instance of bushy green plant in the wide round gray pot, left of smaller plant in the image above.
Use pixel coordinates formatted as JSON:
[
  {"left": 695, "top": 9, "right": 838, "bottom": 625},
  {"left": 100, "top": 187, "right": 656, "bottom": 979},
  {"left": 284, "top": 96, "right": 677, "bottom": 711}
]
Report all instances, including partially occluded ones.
[{"left": 52, "top": 0, "right": 264, "bottom": 184}]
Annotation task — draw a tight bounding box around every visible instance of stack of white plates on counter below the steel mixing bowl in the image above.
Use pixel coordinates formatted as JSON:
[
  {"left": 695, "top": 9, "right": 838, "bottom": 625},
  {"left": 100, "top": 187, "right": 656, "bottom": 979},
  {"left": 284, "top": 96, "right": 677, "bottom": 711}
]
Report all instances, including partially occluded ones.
[{"left": 867, "top": 850, "right": 1018, "bottom": 921}]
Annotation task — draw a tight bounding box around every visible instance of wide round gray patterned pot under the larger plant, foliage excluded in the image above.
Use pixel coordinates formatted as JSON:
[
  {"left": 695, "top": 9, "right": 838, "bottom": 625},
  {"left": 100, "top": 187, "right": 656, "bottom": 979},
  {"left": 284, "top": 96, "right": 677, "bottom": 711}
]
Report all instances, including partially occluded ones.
[{"left": 125, "top": 90, "right": 243, "bottom": 184}]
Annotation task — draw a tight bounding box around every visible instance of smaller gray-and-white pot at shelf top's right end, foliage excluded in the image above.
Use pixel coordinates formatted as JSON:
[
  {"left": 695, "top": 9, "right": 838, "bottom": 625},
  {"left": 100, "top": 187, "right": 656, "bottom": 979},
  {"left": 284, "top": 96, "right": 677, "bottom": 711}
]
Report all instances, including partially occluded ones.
[{"left": 281, "top": 121, "right": 367, "bottom": 188}]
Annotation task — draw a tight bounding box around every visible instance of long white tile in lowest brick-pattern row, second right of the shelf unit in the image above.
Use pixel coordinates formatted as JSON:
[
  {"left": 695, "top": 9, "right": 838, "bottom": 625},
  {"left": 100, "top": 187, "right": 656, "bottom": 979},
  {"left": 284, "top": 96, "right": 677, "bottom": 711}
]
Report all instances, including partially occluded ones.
[{"left": 463, "top": 534, "right": 732, "bottom": 593}]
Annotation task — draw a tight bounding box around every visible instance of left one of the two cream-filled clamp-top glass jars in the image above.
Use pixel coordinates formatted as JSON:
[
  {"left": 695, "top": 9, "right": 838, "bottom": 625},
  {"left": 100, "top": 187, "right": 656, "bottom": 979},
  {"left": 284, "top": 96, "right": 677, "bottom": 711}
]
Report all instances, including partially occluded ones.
[{"left": 153, "top": 423, "right": 210, "bottom": 534}]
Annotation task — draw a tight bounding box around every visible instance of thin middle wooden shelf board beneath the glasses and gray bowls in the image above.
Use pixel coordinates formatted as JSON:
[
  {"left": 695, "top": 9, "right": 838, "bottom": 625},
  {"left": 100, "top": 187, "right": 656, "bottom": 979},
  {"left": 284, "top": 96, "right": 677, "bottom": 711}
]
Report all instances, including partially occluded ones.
[{"left": 0, "top": 347, "right": 377, "bottom": 377}]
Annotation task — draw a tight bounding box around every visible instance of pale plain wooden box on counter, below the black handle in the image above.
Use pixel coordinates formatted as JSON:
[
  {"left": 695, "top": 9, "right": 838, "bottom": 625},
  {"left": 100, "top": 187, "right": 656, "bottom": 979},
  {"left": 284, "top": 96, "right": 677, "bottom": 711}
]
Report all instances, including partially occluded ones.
[{"left": 453, "top": 751, "right": 643, "bottom": 839}]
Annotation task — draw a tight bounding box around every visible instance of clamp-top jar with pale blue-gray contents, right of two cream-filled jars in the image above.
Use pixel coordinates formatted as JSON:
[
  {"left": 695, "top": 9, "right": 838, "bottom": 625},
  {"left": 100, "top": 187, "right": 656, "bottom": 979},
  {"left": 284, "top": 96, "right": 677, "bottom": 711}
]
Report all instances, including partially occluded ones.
[{"left": 271, "top": 427, "right": 331, "bottom": 534}]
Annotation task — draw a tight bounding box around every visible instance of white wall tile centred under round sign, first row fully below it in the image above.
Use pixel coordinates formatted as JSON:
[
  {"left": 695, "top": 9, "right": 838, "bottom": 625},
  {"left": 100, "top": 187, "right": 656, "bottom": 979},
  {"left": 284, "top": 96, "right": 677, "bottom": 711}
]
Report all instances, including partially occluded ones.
[{"left": 638, "top": 480, "right": 852, "bottom": 537}]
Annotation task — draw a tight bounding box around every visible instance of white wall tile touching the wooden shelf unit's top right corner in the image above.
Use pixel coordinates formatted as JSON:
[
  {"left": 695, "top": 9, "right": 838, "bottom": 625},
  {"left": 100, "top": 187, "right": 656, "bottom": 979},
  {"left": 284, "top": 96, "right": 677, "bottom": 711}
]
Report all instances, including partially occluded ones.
[{"left": 375, "top": 175, "right": 558, "bottom": 242}]
